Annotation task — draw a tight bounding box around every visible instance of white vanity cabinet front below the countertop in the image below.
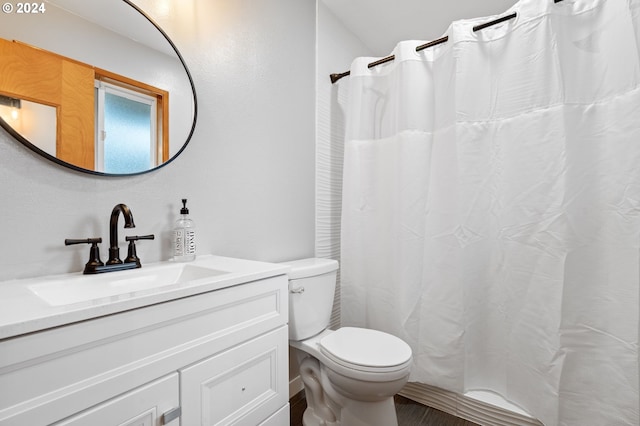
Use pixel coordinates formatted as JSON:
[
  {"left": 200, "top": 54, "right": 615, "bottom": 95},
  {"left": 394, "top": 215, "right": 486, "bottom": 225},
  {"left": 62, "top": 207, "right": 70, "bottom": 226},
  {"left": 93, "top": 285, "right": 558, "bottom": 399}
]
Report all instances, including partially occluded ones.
[{"left": 0, "top": 275, "right": 289, "bottom": 426}]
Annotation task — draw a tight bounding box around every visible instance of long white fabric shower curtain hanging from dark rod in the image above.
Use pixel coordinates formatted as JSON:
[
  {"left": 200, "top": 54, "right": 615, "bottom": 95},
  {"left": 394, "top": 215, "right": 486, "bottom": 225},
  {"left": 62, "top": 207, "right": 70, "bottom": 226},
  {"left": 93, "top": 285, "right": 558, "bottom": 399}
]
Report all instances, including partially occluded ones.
[{"left": 341, "top": 0, "right": 640, "bottom": 426}]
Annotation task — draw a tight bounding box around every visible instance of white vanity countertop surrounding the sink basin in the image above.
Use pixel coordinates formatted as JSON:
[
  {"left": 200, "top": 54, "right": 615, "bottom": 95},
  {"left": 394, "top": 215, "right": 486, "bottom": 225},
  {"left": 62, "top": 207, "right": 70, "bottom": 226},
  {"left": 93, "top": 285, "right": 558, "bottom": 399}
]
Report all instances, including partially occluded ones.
[{"left": 0, "top": 255, "right": 290, "bottom": 339}]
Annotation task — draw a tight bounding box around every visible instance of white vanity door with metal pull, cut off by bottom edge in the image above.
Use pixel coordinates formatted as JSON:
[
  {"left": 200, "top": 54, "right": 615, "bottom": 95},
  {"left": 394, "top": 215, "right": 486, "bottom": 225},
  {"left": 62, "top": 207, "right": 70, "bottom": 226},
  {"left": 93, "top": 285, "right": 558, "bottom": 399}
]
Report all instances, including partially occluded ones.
[{"left": 54, "top": 373, "right": 180, "bottom": 426}]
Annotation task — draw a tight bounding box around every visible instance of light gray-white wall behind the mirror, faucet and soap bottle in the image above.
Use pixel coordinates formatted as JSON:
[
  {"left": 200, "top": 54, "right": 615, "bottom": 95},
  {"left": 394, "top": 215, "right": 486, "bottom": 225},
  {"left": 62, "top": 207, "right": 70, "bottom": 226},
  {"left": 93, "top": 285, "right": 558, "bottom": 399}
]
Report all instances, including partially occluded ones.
[{"left": 0, "top": 0, "right": 315, "bottom": 285}]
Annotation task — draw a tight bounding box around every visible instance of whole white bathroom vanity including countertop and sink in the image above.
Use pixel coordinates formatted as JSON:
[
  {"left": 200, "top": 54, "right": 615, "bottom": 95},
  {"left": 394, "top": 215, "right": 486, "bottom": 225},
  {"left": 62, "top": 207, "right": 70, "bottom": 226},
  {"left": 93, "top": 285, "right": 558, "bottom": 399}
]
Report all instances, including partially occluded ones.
[{"left": 0, "top": 256, "right": 289, "bottom": 426}]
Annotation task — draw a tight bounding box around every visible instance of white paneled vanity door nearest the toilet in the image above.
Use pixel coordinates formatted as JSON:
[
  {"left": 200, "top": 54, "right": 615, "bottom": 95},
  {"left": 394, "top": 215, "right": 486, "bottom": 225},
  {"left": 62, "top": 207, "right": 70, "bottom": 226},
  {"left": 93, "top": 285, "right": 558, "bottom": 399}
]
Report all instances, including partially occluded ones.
[{"left": 180, "top": 326, "right": 289, "bottom": 426}]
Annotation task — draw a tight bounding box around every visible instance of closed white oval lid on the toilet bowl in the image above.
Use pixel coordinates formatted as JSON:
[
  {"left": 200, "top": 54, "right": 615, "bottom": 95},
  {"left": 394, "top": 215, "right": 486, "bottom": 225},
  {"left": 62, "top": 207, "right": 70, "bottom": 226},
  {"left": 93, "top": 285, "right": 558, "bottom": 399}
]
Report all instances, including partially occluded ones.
[{"left": 319, "top": 327, "right": 411, "bottom": 370}]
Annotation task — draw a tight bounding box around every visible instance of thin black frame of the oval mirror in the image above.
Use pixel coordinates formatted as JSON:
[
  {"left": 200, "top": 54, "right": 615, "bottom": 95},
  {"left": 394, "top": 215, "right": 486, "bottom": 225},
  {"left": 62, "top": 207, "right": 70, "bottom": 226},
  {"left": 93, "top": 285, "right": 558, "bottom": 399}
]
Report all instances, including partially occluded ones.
[{"left": 0, "top": 0, "right": 198, "bottom": 177}]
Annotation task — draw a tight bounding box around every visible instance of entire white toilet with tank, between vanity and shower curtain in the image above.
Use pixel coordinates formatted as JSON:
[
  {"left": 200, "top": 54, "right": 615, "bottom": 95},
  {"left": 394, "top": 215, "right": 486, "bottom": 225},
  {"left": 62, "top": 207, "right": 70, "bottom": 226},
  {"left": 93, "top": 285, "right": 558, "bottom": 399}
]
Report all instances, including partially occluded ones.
[{"left": 284, "top": 259, "right": 411, "bottom": 426}]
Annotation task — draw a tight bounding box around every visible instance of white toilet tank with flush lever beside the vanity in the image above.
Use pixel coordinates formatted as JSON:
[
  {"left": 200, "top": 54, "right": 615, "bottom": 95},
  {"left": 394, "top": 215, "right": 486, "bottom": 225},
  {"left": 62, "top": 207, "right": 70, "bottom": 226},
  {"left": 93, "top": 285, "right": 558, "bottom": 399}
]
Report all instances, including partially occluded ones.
[{"left": 283, "top": 258, "right": 338, "bottom": 340}]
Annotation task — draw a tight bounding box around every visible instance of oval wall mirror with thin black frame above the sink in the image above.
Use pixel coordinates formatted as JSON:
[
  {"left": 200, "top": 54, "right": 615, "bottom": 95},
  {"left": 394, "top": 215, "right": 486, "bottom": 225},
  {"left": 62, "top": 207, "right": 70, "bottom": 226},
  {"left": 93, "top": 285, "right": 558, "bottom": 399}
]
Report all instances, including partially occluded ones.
[{"left": 0, "top": 0, "right": 197, "bottom": 176}]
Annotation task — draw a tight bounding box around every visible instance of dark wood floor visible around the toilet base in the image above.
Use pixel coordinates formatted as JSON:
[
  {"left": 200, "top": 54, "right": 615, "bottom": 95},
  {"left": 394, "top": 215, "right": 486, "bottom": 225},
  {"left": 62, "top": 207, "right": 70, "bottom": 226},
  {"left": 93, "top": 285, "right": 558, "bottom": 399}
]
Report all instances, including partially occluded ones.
[{"left": 289, "top": 391, "right": 478, "bottom": 426}]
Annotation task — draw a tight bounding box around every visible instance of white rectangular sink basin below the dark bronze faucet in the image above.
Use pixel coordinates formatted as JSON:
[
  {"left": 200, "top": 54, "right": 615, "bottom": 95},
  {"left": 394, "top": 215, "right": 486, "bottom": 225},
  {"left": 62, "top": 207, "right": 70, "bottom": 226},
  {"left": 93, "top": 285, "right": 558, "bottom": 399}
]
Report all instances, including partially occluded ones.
[{"left": 28, "top": 263, "right": 229, "bottom": 306}]
